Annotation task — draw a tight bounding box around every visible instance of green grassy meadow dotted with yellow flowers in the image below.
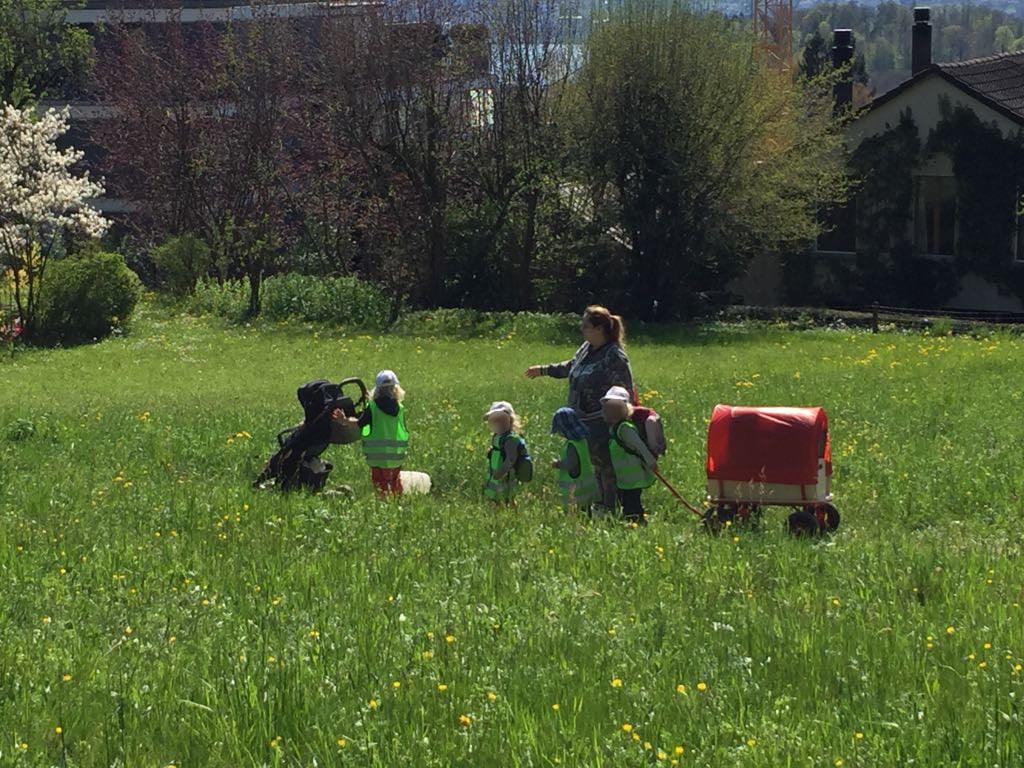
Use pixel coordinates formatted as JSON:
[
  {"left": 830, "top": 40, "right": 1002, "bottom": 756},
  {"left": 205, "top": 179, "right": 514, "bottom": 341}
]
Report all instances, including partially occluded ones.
[{"left": 0, "top": 311, "right": 1024, "bottom": 768}]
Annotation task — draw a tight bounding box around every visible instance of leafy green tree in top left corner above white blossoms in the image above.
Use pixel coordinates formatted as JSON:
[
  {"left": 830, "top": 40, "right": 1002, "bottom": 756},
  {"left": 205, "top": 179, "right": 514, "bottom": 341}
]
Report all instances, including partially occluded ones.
[{"left": 0, "top": 0, "right": 92, "bottom": 109}]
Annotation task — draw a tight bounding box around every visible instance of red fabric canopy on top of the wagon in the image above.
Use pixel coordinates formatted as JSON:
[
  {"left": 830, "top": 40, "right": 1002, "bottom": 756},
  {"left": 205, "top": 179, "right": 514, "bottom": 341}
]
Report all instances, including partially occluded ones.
[{"left": 708, "top": 406, "right": 831, "bottom": 484}]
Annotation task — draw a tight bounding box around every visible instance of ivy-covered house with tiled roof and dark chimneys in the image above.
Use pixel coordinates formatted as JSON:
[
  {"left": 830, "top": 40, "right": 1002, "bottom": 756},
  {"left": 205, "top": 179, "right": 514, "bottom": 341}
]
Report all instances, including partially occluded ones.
[{"left": 739, "top": 8, "right": 1024, "bottom": 312}]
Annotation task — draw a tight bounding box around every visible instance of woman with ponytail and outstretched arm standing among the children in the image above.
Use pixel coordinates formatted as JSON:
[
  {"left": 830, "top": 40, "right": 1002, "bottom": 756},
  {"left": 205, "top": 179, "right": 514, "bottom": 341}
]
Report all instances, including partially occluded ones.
[{"left": 526, "top": 306, "right": 636, "bottom": 510}]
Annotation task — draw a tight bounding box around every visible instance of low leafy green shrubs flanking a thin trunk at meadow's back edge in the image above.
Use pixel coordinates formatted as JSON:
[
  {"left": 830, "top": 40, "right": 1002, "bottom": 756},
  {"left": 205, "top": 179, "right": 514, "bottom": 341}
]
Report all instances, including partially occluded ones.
[{"left": 185, "top": 274, "right": 391, "bottom": 328}]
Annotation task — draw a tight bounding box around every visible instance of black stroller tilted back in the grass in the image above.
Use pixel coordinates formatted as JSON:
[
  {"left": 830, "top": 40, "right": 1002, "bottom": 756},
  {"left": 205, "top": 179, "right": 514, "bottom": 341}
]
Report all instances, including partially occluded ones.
[{"left": 253, "top": 378, "right": 369, "bottom": 492}]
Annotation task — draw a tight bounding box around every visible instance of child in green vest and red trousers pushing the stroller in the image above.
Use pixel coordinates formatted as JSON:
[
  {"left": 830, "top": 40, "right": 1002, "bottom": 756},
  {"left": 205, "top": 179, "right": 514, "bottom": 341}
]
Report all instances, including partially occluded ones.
[{"left": 335, "top": 371, "right": 409, "bottom": 499}]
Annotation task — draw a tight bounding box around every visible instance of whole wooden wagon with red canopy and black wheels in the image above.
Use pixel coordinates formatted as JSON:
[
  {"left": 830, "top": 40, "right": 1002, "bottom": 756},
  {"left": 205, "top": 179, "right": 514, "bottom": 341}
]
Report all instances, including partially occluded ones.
[{"left": 705, "top": 404, "right": 840, "bottom": 535}]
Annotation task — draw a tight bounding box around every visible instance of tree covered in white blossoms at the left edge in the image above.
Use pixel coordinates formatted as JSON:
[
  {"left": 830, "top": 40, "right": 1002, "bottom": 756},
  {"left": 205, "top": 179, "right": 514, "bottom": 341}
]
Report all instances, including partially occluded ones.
[{"left": 0, "top": 104, "right": 109, "bottom": 333}]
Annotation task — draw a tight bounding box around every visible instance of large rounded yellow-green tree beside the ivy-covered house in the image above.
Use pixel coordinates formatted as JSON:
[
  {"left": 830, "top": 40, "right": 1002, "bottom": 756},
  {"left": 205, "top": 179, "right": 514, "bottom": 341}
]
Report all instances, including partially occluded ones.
[{"left": 572, "top": 0, "right": 847, "bottom": 318}]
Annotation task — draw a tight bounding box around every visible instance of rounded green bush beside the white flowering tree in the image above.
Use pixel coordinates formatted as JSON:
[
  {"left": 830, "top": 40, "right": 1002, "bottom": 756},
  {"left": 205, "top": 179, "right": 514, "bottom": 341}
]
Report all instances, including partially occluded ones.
[{"left": 38, "top": 251, "right": 141, "bottom": 344}]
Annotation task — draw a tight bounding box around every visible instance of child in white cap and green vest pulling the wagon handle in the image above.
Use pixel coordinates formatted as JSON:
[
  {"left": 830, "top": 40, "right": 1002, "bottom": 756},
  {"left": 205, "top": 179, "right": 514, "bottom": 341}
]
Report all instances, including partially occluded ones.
[{"left": 601, "top": 387, "right": 657, "bottom": 525}]
